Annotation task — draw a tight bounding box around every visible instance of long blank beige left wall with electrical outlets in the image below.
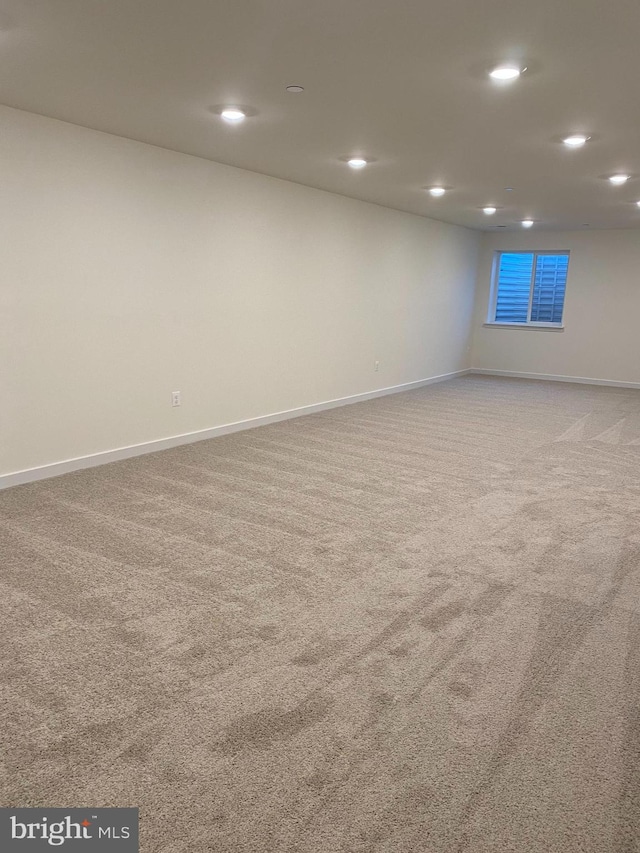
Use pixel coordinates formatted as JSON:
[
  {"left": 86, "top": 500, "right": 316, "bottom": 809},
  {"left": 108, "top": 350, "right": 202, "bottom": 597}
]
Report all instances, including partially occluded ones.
[{"left": 0, "top": 103, "right": 479, "bottom": 474}]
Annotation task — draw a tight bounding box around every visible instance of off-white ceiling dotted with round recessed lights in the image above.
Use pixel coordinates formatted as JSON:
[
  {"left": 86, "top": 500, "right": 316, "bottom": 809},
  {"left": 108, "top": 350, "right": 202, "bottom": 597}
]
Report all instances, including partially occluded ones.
[{"left": 0, "top": 0, "right": 640, "bottom": 229}]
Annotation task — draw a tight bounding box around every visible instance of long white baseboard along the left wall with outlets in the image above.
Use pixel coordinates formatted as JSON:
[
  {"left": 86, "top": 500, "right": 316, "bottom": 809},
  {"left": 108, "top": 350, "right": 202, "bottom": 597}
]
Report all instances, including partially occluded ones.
[{"left": 0, "top": 369, "right": 469, "bottom": 489}]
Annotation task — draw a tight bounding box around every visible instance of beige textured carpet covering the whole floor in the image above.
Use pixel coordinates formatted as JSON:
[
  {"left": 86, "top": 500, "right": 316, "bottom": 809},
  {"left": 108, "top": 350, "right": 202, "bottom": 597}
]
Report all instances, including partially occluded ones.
[{"left": 0, "top": 377, "right": 640, "bottom": 853}]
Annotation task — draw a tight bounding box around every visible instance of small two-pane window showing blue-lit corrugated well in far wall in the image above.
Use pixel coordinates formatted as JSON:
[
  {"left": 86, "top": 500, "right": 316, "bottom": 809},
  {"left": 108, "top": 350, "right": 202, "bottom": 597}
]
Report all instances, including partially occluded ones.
[{"left": 488, "top": 252, "right": 569, "bottom": 326}]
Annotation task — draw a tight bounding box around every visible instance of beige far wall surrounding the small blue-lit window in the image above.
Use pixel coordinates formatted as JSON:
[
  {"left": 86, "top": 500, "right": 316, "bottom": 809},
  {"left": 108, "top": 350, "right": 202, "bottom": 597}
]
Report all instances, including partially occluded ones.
[{"left": 472, "top": 230, "right": 640, "bottom": 383}]
